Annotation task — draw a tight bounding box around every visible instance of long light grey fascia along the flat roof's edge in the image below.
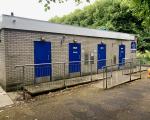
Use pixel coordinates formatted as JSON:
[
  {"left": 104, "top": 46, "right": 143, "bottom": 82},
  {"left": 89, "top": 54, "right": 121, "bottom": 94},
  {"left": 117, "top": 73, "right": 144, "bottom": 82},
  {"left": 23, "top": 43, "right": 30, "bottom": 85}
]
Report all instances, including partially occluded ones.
[{"left": 0, "top": 14, "right": 135, "bottom": 40}]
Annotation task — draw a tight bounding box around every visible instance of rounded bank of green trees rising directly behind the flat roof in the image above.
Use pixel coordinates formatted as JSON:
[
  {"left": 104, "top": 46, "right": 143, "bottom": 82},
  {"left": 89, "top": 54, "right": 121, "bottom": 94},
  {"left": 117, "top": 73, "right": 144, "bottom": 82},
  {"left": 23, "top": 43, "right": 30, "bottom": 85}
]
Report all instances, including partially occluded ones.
[{"left": 50, "top": 0, "right": 143, "bottom": 33}]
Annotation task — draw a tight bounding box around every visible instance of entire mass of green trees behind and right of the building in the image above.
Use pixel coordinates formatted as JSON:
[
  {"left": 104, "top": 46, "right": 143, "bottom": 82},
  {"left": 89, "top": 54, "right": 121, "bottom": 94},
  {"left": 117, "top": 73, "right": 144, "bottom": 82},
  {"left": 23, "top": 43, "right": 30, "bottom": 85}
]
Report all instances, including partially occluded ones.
[{"left": 50, "top": 0, "right": 150, "bottom": 52}]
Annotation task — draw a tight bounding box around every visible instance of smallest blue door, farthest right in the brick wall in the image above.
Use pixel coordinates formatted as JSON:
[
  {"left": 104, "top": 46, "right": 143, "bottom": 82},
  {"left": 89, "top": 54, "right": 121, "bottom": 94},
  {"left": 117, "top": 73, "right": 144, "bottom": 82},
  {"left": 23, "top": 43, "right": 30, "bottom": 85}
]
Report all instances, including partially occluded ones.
[{"left": 119, "top": 44, "right": 126, "bottom": 66}]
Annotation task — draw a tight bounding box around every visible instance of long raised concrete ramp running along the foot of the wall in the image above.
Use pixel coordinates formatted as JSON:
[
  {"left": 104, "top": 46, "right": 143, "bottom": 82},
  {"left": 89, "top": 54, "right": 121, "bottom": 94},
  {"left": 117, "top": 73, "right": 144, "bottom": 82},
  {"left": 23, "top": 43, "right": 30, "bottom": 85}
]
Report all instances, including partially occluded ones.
[{"left": 24, "top": 73, "right": 103, "bottom": 95}]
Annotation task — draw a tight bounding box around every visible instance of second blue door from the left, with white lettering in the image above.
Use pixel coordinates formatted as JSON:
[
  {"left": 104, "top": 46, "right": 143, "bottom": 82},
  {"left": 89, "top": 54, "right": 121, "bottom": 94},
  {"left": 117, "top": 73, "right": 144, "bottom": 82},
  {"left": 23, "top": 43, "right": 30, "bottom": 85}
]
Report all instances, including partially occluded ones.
[{"left": 69, "top": 43, "right": 81, "bottom": 73}]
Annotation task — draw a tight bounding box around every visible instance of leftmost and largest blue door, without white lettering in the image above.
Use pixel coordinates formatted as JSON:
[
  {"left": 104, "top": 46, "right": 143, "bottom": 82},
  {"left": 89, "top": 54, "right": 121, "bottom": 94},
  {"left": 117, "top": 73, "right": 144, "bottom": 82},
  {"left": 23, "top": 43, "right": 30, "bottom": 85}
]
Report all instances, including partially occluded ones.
[{"left": 34, "top": 41, "right": 51, "bottom": 78}]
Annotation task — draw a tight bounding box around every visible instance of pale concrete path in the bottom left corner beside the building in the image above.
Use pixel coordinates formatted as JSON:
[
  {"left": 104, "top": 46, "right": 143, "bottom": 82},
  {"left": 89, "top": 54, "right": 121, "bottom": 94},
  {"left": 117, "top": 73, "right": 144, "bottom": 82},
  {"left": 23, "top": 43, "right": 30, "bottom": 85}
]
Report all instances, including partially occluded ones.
[{"left": 0, "top": 87, "right": 13, "bottom": 108}]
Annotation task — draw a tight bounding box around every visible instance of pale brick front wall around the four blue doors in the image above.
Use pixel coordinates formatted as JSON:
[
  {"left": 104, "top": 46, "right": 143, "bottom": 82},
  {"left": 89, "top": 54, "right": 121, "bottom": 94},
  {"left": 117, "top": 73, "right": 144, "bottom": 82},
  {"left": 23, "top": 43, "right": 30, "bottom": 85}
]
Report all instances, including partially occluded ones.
[{"left": 2, "top": 29, "right": 135, "bottom": 90}]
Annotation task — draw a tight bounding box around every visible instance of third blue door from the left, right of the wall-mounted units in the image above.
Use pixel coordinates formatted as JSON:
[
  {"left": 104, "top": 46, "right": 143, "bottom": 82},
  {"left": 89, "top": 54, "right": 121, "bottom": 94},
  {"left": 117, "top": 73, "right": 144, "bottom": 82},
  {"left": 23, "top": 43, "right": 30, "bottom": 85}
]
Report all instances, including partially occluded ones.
[{"left": 97, "top": 43, "right": 106, "bottom": 69}]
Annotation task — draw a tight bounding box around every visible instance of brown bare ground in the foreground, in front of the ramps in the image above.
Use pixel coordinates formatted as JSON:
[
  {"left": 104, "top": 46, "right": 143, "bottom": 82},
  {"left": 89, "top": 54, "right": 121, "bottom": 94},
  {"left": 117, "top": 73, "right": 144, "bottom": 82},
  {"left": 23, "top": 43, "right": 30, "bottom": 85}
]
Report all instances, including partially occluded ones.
[{"left": 0, "top": 71, "right": 150, "bottom": 120}]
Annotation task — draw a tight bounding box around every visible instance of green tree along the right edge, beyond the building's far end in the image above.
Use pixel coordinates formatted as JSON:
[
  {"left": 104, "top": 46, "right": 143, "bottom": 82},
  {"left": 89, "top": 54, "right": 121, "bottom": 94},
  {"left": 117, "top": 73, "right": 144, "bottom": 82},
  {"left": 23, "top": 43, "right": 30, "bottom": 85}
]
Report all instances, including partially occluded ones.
[{"left": 126, "top": 0, "right": 150, "bottom": 52}]
